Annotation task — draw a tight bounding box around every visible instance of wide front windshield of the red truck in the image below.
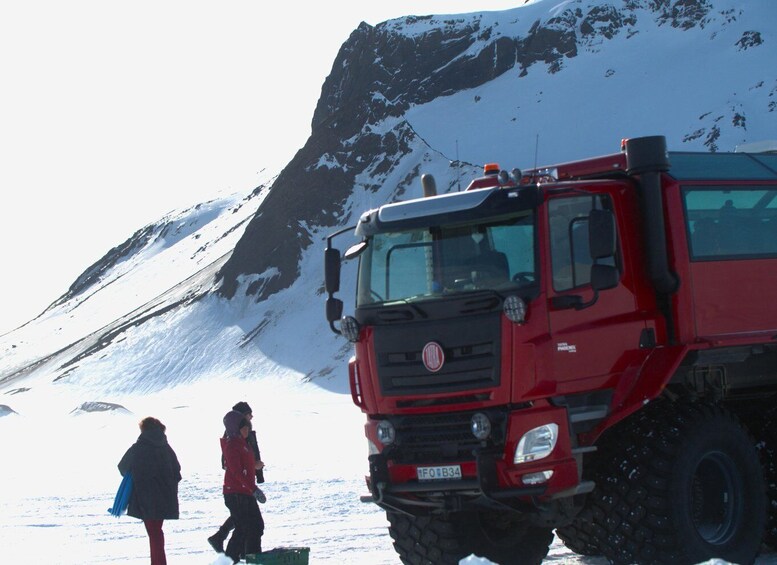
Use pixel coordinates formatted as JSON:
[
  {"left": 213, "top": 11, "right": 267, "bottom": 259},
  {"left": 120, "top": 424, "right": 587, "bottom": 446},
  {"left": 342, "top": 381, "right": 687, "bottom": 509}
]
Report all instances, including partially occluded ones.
[{"left": 356, "top": 211, "right": 536, "bottom": 307}]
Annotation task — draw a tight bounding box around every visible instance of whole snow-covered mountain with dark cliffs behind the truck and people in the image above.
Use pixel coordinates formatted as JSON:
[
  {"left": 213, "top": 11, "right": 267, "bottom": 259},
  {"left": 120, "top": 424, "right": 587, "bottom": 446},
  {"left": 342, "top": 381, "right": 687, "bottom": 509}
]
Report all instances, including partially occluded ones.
[{"left": 0, "top": 0, "right": 777, "bottom": 398}]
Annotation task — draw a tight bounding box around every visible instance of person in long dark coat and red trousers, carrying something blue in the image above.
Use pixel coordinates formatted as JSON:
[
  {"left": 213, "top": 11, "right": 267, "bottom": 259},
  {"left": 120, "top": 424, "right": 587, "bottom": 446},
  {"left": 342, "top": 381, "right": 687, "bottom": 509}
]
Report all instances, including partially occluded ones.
[{"left": 119, "top": 417, "right": 181, "bottom": 565}]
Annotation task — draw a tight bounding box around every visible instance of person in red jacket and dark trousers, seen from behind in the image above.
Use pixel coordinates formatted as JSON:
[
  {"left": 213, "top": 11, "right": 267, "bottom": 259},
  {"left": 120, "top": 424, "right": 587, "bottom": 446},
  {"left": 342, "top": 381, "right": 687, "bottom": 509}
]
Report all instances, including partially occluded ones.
[{"left": 221, "top": 410, "right": 264, "bottom": 563}]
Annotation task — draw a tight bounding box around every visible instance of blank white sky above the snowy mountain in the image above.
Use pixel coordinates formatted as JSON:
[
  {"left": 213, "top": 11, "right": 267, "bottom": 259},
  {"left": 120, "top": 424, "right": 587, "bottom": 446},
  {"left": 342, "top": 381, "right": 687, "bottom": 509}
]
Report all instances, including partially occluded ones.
[{"left": 0, "top": 0, "right": 521, "bottom": 334}]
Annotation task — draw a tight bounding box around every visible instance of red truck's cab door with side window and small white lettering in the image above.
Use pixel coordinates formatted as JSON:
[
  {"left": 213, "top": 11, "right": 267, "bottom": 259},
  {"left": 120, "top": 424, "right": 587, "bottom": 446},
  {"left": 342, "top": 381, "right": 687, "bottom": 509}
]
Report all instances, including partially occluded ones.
[{"left": 545, "top": 190, "right": 645, "bottom": 394}]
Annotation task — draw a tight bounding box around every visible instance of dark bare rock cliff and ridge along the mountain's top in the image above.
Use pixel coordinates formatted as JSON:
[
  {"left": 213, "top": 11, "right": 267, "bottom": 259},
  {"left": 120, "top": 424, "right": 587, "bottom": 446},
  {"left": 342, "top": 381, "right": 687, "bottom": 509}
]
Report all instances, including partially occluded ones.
[{"left": 212, "top": 0, "right": 760, "bottom": 300}]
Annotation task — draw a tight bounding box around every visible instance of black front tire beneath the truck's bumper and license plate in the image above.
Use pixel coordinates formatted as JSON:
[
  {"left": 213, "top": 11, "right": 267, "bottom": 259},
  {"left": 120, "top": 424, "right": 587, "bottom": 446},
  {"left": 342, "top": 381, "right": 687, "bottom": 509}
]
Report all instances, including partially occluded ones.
[{"left": 386, "top": 512, "right": 553, "bottom": 565}]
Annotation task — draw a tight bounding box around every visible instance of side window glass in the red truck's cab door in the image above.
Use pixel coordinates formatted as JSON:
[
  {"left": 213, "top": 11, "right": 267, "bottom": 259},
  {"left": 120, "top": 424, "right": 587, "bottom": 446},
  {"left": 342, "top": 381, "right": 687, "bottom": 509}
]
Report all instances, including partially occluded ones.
[{"left": 548, "top": 195, "right": 615, "bottom": 291}]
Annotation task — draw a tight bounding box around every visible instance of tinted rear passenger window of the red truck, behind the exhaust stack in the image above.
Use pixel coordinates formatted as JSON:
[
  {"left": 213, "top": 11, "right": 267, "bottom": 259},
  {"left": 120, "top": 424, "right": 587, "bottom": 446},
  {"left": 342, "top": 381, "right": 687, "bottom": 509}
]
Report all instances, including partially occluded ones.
[{"left": 683, "top": 186, "right": 777, "bottom": 261}]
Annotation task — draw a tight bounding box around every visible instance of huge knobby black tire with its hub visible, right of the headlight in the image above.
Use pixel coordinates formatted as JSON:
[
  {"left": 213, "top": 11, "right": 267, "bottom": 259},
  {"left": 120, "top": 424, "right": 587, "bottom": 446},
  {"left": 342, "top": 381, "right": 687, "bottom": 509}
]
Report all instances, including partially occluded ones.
[{"left": 592, "top": 402, "right": 766, "bottom": 564}]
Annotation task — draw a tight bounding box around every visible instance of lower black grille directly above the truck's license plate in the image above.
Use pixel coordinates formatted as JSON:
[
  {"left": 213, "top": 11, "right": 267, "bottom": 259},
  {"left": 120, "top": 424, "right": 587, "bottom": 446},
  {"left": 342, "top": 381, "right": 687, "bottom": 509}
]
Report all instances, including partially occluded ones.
[{"left": 389, "top": 410, "right": 507, "bottom": 464}]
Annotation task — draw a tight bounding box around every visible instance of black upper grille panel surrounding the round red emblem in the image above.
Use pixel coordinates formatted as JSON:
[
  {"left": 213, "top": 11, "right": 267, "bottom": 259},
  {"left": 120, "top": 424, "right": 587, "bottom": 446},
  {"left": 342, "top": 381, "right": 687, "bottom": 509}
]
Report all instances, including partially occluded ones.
[{"left": 375, "top": 312, "right": 501, "bottom": 396}]
